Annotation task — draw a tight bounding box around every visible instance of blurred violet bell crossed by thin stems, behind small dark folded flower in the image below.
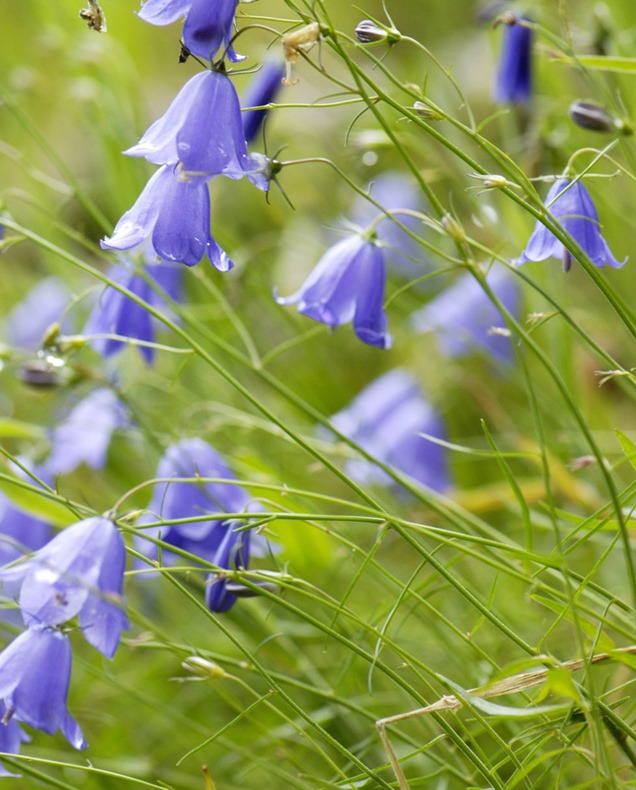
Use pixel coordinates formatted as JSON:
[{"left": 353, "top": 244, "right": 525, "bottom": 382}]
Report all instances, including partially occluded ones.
[{"left": 135, "top": 438, "right": 252, "bottom": 564}]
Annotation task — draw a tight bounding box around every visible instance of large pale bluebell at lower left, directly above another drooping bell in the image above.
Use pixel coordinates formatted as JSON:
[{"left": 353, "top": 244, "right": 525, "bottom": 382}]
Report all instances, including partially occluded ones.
[{"left": 0, "top": 517, "right": 130, "bottom": 658}]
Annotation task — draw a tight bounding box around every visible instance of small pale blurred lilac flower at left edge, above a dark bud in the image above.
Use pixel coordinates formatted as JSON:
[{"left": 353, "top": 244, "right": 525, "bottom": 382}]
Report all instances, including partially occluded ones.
[{"left": 6, "top": 277, "right": 71, "bottom": 351}]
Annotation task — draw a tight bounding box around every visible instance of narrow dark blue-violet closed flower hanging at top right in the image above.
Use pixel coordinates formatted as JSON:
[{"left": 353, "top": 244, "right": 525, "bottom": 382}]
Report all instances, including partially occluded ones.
[{"left": 494, "top": 18, "right": 533, "bottom": 104}]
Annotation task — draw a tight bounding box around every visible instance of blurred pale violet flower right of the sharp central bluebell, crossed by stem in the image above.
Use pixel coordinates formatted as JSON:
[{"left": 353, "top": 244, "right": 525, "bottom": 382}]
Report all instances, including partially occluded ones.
[{"left": 411, "top": 266, "right": 519, "bottom": 362}]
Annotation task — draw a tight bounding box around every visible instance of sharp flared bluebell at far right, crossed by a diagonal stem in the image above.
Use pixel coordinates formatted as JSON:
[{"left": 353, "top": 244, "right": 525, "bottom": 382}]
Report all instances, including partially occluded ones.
[{"left": 516, "top": 178, "right": 627, "bottom": 271}]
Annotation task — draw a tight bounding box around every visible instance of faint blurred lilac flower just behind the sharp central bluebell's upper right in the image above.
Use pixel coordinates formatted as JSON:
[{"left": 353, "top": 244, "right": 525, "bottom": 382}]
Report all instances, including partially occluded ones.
[{"left": 351, "top": 172, "right": 430, "bottom": 277}]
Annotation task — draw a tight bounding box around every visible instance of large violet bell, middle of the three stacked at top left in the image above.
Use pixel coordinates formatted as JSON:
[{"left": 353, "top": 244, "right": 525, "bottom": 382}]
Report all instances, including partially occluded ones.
[{"left": 124, "top": 69, "right": 269, "bottom": 190}]
